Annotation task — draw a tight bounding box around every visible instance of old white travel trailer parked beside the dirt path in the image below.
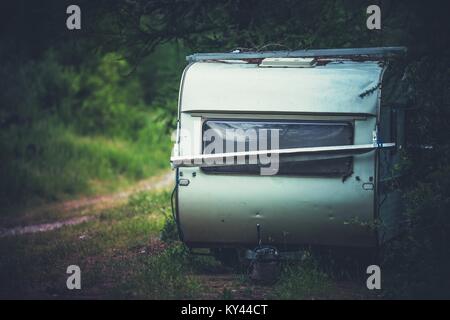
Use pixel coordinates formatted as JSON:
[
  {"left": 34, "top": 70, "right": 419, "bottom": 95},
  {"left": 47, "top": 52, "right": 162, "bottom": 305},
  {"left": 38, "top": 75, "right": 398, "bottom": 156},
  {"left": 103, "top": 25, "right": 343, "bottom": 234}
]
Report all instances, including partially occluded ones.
[{"left": 171, "top": 47, "right": 406, "bottom": 262}]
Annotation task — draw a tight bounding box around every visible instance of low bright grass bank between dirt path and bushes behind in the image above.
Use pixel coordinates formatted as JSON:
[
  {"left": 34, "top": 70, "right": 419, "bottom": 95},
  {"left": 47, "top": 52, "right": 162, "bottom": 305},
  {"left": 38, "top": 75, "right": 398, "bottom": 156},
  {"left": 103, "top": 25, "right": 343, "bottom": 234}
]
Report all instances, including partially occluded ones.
[{"left": 0, "top": 119, "right": 170, "bottom": 215}]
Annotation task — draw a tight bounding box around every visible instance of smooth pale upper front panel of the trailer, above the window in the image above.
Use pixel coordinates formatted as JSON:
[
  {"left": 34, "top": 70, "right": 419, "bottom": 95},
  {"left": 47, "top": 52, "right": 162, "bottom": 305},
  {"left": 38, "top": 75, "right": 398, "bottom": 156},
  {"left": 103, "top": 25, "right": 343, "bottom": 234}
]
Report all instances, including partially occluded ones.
[{"left": 181, "top": 61, "right": 382, "bottom": 115}]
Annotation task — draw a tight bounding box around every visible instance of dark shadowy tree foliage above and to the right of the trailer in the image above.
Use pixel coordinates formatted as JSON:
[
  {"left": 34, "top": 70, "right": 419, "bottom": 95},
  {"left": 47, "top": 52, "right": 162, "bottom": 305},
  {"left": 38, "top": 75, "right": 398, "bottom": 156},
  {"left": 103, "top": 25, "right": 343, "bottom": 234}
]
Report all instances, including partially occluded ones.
[{"left": 0, "top": 0, "right": 450, "bottom": 297}]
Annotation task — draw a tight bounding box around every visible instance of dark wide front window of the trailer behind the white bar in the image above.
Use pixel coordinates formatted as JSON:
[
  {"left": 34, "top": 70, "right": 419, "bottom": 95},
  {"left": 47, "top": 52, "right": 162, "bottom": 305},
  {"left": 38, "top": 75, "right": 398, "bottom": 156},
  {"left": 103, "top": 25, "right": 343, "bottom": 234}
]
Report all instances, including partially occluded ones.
[{"left": 202, "top": 120, "right": 353, "bottom": 176}]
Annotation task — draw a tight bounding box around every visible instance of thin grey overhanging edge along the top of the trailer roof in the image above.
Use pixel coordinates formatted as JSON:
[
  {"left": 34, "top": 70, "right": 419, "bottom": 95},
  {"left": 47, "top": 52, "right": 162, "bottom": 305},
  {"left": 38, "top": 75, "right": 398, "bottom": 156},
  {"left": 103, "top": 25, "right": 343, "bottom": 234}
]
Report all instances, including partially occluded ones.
[{"left": 186, "top": 47, "right": 407, "bottom": 62}]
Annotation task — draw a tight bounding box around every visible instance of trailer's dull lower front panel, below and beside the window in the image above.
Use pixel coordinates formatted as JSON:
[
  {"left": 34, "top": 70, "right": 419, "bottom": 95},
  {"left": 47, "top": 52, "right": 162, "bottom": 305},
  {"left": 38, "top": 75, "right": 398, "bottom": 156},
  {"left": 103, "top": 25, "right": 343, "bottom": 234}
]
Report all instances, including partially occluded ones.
[{"left": 178, "top": 113, "right": 376, "bottom": 249}]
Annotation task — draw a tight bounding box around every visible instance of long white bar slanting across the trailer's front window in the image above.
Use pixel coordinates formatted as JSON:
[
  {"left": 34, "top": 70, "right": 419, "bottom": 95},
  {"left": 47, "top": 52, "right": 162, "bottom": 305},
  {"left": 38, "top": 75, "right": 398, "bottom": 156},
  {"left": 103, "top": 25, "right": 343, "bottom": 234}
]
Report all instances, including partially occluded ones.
[{"left": 170, "top": 143, "right": 395, "bottom": 168}]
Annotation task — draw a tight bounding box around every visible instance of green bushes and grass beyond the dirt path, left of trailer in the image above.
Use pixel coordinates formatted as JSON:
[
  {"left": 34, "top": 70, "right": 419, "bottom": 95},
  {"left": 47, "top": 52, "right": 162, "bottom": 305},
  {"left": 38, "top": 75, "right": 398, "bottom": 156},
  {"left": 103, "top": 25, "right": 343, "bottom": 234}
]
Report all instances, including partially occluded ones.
[{"left": 0, "top": 48, "right": 181, "bottom": 215}]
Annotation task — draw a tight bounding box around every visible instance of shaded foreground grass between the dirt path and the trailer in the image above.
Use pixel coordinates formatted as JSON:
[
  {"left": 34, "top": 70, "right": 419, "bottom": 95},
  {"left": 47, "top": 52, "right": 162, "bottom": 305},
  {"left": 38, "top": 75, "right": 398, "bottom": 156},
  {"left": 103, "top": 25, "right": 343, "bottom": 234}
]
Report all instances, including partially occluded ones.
[{"left": 0, "top": 192, "right": 204, "bottom": 299}]
